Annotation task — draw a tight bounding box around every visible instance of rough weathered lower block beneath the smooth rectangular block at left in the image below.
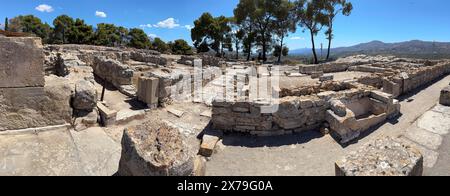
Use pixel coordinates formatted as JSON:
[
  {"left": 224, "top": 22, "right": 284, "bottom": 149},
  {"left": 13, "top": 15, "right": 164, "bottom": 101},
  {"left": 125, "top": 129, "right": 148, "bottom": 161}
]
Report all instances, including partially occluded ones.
[{"left": 0, "top": 77, "right": 73, "bottom": 131}]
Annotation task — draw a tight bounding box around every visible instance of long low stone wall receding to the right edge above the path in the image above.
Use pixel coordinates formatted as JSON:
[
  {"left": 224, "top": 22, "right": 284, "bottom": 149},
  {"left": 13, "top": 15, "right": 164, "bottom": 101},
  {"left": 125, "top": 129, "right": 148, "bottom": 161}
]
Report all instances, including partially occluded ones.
[{"left": 383, "top": 62, "right": 450, "bottom": 97}]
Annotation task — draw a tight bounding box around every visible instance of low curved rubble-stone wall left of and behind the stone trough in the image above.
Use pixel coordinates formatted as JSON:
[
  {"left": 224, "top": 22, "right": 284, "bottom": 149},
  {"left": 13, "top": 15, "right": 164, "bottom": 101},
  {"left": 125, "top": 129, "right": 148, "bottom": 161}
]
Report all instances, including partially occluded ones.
[{"left": 212, "top": 82, "right": 384, "bottom": 136}]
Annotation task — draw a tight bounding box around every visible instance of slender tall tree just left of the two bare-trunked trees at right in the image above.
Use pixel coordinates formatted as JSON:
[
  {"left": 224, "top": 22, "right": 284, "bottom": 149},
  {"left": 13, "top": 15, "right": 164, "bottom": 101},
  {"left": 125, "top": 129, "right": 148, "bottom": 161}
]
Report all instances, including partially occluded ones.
[{"left": 274, "top": 0, "right": 297, "bottom": 63}]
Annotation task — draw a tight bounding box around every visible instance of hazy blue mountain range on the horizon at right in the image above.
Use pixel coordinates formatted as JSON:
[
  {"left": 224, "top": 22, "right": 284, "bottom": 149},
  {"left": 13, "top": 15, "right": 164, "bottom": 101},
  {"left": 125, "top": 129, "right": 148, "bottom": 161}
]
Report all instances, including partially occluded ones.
[{"left": 290, "top": 40, "right": 450, "bottom": 58}]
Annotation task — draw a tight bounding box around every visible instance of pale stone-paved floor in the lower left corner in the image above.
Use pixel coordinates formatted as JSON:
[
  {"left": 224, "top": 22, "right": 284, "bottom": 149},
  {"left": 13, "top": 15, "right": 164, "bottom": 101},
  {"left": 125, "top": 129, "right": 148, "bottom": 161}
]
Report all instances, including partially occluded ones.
[{"left": 0, "top": 128, "right": 121, "bottom": 176}]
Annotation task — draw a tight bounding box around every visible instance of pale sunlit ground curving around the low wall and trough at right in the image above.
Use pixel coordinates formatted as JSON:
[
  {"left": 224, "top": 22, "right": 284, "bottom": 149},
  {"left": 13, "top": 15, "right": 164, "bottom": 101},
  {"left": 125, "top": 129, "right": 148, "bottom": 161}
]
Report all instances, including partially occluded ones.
[{"left": 206, "top": 76, "right": 450, "bottom": 176}]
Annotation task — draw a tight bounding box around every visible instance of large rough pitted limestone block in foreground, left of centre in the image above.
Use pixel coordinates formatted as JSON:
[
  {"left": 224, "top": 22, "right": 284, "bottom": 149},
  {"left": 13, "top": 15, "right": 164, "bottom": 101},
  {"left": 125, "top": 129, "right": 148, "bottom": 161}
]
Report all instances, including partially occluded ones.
[{"left": 117, "top": 121, "right": 196, "bottom": 176}]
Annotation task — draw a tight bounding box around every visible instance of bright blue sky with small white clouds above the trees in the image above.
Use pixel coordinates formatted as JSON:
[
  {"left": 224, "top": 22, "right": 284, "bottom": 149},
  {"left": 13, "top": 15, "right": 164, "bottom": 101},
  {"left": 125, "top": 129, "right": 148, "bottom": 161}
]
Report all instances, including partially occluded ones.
[{"left": 0, "top": 0, "right": 450, "bottom": 49}]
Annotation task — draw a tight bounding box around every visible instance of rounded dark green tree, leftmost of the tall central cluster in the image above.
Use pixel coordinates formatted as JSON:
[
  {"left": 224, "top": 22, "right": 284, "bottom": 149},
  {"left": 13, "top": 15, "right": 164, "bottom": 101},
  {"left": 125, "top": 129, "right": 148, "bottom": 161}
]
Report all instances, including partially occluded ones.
[{"left": 191, "top": 13, "right": 231, "bottom": 56}]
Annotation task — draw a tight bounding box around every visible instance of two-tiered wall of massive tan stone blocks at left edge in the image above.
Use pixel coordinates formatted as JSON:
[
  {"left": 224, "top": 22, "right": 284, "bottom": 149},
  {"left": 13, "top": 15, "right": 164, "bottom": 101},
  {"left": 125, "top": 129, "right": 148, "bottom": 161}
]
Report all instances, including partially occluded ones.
[{"left": 0, "top": 37, "right": 73, "bottom": 131}]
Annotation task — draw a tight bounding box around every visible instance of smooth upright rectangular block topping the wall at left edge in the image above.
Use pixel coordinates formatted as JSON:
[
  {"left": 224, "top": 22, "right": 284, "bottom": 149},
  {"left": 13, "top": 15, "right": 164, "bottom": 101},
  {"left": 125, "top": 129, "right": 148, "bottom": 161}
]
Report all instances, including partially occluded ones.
[{"left": 0, "top": 37, "right": 45, "bottom": 88}]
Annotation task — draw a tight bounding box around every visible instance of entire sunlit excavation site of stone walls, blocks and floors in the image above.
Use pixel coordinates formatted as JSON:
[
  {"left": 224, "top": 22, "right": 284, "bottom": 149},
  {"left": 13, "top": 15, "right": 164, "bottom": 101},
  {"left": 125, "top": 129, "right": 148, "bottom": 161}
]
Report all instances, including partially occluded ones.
[{"left": 0, "top": 35, "right": 450, "bottom": 176}]
